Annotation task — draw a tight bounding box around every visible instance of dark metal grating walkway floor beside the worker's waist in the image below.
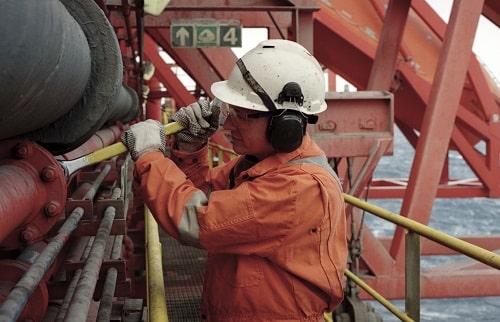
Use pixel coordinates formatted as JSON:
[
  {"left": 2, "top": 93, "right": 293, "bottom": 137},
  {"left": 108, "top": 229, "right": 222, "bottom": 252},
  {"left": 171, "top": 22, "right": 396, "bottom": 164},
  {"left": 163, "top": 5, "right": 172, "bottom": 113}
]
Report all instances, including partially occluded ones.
[{"left": 160, "top": 232, "right": 207, "bottom": 322}]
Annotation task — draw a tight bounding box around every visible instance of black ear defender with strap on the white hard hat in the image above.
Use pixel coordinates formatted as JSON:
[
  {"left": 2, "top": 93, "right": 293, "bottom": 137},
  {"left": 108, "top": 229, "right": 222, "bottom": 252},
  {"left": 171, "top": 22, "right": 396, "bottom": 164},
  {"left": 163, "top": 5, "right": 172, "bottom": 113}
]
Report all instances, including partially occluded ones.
[{"left": 236, "top": 59, "right": 308, "bottom": 152}]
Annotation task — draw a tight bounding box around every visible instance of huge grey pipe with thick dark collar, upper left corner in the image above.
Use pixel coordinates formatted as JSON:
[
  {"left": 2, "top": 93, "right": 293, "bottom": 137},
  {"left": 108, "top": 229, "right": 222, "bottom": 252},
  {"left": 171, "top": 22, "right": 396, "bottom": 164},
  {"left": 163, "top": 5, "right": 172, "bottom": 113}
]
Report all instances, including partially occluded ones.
[{"left": 0, "top": 0, "right": 138, "bottom": 154}]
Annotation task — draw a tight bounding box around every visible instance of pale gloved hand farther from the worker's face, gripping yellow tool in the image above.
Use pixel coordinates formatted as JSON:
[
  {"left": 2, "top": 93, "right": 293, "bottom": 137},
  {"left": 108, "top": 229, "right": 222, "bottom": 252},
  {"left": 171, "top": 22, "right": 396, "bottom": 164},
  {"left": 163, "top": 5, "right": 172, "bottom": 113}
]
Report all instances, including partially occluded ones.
[{"left": 120, "top": 120, "right": 167, "bottom": 161}]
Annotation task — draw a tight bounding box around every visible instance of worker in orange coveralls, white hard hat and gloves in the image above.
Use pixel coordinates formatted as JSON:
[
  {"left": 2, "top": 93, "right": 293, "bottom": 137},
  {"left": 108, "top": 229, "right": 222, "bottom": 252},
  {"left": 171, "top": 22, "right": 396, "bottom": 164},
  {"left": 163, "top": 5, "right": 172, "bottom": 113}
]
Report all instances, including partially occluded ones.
[{"left": 122, "top": 40, "right": 347, "bottom": 321}]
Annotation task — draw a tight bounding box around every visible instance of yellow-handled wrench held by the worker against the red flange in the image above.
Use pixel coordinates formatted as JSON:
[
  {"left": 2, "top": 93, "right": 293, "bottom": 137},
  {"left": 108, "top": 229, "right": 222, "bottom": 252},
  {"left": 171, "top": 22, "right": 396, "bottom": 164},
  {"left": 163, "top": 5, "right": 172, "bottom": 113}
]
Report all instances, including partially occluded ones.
[{"left": 59, "top": 122, "right": 183, "bottom": 178}]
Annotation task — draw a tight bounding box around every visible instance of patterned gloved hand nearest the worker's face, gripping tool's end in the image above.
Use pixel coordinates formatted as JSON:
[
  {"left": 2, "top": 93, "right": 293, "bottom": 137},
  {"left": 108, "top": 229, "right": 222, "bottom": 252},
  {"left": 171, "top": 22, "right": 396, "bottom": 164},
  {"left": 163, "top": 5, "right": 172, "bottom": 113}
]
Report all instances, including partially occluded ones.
[{"left": 172, "top": 99, "right": 220, "bottom": 150}]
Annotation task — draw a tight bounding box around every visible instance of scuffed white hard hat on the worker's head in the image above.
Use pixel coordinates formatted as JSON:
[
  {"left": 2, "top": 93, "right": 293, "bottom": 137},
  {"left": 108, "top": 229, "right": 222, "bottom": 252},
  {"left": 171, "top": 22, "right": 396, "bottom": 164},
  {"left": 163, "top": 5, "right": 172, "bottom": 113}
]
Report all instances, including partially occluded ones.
[{"left": 211, "top": 39, "right": 326, "bottom": 115}]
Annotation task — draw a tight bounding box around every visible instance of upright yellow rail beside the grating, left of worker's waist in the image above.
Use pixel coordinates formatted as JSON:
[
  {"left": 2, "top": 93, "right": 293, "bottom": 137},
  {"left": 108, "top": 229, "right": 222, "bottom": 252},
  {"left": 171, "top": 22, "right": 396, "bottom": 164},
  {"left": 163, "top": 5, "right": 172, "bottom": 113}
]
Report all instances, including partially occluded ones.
[{"left": 144, "top": 207, "right": 168, "bottom": 322}]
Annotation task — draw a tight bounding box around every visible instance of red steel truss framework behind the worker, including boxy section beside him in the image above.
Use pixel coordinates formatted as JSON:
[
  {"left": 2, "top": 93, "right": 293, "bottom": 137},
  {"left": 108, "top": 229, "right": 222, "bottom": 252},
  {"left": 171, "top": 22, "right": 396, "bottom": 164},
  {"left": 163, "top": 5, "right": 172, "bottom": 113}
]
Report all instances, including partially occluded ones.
[{"left": 109, "top": 0, "right": 500, "bottom": 298}]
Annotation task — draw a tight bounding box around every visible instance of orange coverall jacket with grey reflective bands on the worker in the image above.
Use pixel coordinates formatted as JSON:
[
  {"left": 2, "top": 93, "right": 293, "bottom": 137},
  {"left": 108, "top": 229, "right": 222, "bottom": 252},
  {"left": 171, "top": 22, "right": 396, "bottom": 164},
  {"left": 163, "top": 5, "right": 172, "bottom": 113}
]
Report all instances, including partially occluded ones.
[{"left": 135, "top": 135, "right": 347, "bottom": 321}]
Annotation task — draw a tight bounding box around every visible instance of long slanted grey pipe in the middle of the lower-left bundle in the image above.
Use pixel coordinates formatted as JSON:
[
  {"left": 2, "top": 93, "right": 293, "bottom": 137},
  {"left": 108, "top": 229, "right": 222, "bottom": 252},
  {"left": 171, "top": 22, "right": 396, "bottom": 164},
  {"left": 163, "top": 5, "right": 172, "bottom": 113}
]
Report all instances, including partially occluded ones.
[{"left": 65, "top": 206, "right": 116, "bottom": 322}]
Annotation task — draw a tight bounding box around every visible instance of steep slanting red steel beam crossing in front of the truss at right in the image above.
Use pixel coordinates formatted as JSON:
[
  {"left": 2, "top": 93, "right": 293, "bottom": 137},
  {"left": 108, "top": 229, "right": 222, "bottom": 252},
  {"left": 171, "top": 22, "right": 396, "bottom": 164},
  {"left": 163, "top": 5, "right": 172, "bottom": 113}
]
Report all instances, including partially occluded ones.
[{"left": 391, "top": 0, "right": 482, "bottom": 267}]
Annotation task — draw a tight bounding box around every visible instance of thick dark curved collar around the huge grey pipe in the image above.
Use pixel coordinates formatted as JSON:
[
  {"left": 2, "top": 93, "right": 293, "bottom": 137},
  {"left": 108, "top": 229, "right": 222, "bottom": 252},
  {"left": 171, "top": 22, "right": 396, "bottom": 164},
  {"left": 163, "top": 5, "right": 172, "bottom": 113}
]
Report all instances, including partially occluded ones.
[{"left": 27, "top": 0, "right": 137, "bottom": 154}]
